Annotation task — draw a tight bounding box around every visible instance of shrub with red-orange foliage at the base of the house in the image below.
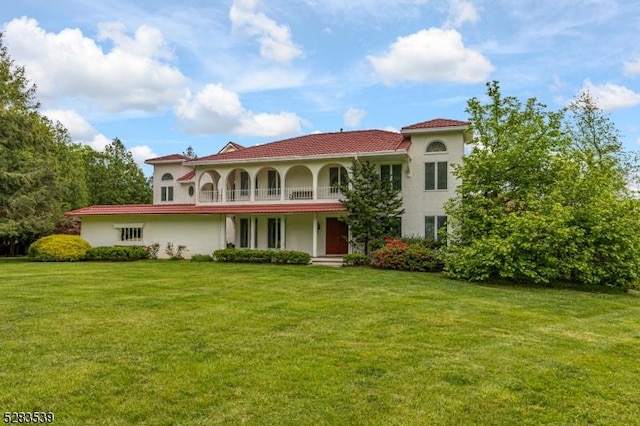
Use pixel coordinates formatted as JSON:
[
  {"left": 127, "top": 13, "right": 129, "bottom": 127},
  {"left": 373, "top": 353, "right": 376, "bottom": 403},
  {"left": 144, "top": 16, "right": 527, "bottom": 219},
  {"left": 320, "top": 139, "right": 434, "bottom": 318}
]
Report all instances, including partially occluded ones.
[{"left": 373, "top": 238, "right": 442, "bottom": 272}]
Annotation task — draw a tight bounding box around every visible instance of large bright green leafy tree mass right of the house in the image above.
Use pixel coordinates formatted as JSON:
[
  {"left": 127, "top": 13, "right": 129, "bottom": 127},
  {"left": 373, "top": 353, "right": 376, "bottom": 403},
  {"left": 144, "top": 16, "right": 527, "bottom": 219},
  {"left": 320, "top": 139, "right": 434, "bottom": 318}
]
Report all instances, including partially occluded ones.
[{"left": 446, "top": 82, "right": 640, "bottom": 286}]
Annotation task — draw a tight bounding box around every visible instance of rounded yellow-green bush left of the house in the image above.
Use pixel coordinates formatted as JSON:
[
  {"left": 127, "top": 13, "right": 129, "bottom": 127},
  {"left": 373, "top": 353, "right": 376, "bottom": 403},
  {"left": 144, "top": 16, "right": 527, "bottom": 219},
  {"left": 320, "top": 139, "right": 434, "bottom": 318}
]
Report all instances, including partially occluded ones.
[{"left": 27, "top": 234, "right": 91, "bottom": 262}]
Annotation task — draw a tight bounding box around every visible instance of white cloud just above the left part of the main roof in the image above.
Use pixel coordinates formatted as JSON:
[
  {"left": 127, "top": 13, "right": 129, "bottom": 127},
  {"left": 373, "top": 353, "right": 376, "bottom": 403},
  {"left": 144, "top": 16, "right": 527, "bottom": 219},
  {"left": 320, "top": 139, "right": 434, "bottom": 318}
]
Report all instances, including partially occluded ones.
[{"left": 175, "top": 84, "right": 303, "bottom": 136}]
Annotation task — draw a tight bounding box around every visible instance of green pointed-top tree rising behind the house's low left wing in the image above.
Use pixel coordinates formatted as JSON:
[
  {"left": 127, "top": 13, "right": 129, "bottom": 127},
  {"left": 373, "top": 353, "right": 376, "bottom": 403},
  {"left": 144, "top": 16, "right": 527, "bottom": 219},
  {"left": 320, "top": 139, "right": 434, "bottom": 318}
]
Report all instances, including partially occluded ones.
[{"left": 85, "top": 138, "right": 152, "bottom": 204}]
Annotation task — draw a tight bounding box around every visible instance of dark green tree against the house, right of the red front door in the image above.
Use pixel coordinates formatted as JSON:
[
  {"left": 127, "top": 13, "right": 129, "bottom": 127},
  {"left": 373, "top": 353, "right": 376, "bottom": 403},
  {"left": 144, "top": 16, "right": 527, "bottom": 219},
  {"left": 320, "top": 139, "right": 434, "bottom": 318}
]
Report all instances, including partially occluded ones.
[{"left": 340, "top": 160, "right": 404, "bottom": 255}]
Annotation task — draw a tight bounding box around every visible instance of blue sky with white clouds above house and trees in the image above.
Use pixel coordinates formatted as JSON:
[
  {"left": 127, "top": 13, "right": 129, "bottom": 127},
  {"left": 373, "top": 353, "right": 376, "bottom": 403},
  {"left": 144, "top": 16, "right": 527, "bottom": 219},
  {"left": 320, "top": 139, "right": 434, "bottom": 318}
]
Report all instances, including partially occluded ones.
[{"left": 0, "top": 0, "right": 640, "bottom": 172}]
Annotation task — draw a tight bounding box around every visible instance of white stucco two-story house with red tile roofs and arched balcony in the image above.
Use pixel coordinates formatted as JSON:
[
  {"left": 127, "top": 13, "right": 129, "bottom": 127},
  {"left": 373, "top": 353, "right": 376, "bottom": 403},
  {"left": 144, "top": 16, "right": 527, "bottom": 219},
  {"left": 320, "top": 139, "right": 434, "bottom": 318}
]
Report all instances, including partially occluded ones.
[{"left": 67, "top": 119, "right": 468, "bottom": 257}]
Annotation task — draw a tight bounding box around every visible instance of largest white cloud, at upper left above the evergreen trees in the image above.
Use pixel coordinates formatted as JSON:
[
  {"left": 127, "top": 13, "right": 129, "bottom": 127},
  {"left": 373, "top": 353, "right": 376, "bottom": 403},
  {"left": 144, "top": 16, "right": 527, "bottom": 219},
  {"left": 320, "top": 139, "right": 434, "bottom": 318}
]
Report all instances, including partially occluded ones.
[{"left": 4, "top": 18, "right": 188, "bottom": 112}]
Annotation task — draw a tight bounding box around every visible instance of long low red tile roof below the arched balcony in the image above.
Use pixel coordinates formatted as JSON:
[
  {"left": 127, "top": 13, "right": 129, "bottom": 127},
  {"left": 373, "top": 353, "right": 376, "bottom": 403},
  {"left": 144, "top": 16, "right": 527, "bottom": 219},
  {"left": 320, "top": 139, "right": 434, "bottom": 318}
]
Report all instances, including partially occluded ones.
[{"left": 65, "top": 201, "right": 346, "bottom": 216}]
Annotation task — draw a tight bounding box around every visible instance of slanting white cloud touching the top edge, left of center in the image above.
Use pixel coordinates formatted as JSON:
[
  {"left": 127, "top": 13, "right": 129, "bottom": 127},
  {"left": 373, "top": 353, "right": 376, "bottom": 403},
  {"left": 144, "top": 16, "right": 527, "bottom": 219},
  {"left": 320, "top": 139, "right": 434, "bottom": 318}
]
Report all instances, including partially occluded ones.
[{"left": 229, "top": 0, "right": 302, "bottom": 64}]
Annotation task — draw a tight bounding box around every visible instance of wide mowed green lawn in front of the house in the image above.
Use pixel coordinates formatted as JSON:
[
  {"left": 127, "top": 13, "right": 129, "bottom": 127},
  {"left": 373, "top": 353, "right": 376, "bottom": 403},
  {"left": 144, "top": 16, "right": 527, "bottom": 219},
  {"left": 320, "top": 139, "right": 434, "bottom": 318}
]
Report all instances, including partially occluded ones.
[{"left": 0, "top": 260, "right": 640, "bottom": 425}]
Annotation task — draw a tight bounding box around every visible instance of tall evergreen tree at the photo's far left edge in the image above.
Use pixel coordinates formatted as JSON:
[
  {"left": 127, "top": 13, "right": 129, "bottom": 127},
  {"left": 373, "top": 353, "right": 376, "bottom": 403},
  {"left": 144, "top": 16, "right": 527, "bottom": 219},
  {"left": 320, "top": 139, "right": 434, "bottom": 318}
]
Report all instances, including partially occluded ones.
[{"left": 0, "top": 34, "right": 62, "bottom": 255}]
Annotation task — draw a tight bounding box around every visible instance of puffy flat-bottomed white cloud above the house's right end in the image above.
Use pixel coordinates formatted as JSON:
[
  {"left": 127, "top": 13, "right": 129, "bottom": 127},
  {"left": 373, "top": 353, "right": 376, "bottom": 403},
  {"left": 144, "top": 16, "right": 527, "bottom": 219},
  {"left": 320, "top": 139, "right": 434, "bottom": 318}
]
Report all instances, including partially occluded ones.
[{"left": 367, "top": 28, "right": 494, "bottom": 84}]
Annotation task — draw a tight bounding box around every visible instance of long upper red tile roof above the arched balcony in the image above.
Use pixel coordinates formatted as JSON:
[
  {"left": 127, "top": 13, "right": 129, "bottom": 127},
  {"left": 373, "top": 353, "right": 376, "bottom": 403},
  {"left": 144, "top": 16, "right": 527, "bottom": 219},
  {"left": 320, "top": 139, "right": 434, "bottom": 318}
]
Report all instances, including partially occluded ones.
[{"left": 186, "top": 130, "right": 407, "bottom": 164}]
